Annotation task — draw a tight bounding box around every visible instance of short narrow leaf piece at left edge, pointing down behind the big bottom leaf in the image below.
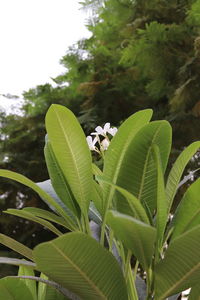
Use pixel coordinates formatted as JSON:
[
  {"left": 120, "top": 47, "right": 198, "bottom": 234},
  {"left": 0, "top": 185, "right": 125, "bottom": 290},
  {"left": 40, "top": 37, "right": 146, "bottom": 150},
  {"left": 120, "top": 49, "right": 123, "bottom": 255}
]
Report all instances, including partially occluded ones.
[{"left": 0, "top": 233, "right": 33, "bottom": 260}]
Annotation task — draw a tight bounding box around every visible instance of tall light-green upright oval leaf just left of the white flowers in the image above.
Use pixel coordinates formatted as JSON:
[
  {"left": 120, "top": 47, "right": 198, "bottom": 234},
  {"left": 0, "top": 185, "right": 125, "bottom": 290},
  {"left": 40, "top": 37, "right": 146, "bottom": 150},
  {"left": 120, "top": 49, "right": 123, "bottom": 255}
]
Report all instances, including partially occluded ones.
[{"left": 46, "top": 104, "right": 92, "bottom": 215}]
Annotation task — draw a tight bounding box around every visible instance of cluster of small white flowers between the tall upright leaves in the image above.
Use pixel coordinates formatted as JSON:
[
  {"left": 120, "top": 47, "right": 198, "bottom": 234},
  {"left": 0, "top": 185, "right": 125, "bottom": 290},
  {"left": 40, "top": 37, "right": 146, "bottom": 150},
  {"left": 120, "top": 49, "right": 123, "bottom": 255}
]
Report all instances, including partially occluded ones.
[{"left": 86, "top": 123, "right": 117, "bottom": 153}]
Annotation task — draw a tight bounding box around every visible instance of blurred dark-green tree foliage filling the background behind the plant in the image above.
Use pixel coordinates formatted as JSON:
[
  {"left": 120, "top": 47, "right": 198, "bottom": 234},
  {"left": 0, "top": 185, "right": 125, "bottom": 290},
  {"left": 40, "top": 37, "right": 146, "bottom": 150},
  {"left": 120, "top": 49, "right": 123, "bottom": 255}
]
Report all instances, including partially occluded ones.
[{"left": 0, "top": 0, "right": 200, "bottom": 276}]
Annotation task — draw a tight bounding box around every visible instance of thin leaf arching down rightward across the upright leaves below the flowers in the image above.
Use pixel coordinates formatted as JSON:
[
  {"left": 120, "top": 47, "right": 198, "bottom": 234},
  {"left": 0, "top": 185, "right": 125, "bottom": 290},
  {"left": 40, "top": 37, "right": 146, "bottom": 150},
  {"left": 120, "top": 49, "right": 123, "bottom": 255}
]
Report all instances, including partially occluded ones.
[{"left": 97, "top": 176, "right": 149, "bottom": 224}]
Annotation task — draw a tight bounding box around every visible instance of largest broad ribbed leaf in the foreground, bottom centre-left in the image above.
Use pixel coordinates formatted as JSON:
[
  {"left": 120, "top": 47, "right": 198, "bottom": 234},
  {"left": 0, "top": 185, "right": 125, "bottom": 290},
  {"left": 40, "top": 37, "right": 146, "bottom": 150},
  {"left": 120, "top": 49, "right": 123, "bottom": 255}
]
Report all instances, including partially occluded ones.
[{"left": 33, "top": 233, "right": 128, "bottom": 300}]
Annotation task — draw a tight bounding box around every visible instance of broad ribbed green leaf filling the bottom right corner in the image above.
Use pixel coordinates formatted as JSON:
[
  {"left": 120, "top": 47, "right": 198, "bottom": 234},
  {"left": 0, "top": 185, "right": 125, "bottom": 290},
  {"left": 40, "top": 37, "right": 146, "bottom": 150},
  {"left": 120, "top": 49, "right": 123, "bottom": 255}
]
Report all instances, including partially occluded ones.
[{"left": 155, "top": 225, "right": 200, "bottom": 300}]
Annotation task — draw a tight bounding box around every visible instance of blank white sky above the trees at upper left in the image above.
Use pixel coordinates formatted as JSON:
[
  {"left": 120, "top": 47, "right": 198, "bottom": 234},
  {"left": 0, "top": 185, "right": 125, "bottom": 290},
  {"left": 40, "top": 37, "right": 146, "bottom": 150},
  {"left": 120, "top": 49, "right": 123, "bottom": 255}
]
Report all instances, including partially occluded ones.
[{"left": 0, "top": 0, "right": 89, "bottom": 112}]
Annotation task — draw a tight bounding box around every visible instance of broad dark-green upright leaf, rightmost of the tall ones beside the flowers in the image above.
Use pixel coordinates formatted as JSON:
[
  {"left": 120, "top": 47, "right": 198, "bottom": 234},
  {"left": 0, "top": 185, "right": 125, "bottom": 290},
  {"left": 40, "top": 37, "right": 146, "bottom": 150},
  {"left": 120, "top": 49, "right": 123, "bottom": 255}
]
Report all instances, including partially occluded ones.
[{"left": 107, "top": 121, "right": 171, "bottom": 212}]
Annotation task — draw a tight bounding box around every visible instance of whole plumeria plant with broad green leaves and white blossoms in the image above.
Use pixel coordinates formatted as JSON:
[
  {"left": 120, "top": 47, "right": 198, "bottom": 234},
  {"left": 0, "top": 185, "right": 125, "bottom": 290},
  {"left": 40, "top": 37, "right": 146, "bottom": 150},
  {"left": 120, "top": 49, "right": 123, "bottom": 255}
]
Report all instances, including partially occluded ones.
[{"left": 0, "top": 105, "right": 200, "bottom": 300}]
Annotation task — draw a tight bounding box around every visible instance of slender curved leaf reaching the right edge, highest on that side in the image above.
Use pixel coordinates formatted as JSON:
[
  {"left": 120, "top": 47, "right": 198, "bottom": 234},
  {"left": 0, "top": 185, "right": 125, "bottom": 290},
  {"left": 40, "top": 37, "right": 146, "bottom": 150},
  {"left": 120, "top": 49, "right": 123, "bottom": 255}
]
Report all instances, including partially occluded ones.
[{"left": 166, "top": 141, "right": 200, "bottom": 213}]
